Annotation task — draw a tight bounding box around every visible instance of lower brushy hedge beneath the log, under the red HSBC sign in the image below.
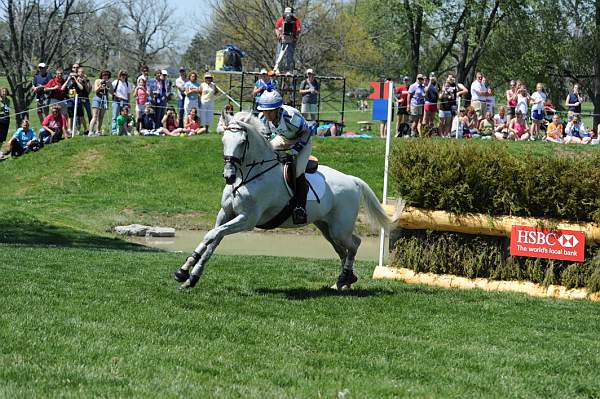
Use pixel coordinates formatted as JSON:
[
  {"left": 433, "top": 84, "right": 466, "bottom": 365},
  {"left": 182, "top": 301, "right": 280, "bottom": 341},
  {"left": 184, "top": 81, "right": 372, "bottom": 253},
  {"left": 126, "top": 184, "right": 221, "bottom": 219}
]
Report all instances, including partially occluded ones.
[{"left": 391, "top": 230, "right": 600, "bottom": 292}]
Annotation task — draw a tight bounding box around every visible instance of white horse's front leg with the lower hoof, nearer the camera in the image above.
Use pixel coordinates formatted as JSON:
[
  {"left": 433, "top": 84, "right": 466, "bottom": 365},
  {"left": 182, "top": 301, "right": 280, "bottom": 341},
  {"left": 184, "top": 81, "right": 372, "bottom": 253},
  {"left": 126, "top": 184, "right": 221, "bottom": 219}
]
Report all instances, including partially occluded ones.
[{"left": 181, "top": 214, "right": 256, "bottom": 289}]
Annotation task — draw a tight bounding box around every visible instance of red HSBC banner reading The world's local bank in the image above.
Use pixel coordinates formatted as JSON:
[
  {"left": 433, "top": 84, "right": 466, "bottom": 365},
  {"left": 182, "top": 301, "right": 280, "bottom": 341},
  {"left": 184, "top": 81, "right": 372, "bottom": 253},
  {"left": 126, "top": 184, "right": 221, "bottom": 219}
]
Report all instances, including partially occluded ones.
[{"left": 510, "top": 226, "right": 585, "bottom": 262}]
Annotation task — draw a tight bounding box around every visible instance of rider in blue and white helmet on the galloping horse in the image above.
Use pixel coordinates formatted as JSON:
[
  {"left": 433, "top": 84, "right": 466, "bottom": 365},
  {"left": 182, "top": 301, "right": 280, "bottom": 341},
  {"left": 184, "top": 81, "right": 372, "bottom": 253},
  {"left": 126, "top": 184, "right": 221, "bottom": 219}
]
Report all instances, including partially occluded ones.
[{"left": 256, "top": 90, "right": 312, "bottom": 224}]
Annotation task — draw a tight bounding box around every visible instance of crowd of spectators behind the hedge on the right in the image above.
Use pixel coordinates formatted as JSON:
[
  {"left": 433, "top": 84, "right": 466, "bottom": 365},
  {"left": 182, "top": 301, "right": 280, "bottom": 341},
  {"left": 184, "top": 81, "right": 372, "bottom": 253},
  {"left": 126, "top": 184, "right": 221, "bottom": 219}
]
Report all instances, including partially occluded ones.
[{"left": 392, "top": 72, "right": 600, "bottom": 144}]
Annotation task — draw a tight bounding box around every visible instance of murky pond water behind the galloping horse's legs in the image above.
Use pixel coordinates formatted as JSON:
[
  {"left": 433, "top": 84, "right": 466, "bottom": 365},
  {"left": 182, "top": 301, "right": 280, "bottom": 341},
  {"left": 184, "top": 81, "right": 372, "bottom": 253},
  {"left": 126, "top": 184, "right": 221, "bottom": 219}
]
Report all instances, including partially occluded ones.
[{"left": 132, "top": 230, "right": 387, "bottom": 261}]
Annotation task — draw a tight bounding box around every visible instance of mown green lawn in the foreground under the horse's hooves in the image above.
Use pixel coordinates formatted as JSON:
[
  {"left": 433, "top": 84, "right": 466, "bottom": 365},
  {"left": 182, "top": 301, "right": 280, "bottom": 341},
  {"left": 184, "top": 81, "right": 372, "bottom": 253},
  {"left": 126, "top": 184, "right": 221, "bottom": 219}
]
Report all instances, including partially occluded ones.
[{"left": 0, "top": 245, "right": 600, "bottom": 398}]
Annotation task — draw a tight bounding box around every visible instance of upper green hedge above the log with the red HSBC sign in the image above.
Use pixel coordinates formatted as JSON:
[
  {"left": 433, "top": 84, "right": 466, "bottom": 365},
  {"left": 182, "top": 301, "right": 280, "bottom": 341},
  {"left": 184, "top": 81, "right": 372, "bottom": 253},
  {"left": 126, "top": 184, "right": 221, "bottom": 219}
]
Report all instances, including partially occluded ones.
[{"left": 391, "top": 139, "right": 600, "bottom": 222}]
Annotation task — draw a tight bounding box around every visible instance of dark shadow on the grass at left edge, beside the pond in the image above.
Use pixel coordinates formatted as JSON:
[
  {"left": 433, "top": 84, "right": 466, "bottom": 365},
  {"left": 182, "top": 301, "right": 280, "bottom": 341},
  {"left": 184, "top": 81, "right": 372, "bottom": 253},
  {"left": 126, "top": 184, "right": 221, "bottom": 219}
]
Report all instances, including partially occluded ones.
[{"left": 0, "top": 212, "right": 149, "bottom": 251}]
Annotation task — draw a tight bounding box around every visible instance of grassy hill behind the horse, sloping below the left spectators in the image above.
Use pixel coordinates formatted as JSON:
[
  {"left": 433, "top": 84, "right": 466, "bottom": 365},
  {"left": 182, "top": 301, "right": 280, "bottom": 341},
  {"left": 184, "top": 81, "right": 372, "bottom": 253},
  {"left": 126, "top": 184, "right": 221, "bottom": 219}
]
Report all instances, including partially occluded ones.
[{"left": 0, "top": 135, "right": 384, "bottom": 241}]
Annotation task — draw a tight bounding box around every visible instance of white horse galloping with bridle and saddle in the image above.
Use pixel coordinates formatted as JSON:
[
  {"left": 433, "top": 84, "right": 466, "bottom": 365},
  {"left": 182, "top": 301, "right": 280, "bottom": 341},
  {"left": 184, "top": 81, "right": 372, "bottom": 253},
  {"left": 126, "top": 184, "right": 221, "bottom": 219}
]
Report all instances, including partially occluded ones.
[{"left": 175, "top": 112, "right": 390, "bottom": 289}]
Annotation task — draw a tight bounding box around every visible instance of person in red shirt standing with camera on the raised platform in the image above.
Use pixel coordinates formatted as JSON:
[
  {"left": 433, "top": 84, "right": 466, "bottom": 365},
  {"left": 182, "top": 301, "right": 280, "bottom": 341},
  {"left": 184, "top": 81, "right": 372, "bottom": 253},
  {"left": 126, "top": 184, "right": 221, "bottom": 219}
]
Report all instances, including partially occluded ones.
[{"left": 273, "top": 7, "right": 302, "bottom": 72}]
